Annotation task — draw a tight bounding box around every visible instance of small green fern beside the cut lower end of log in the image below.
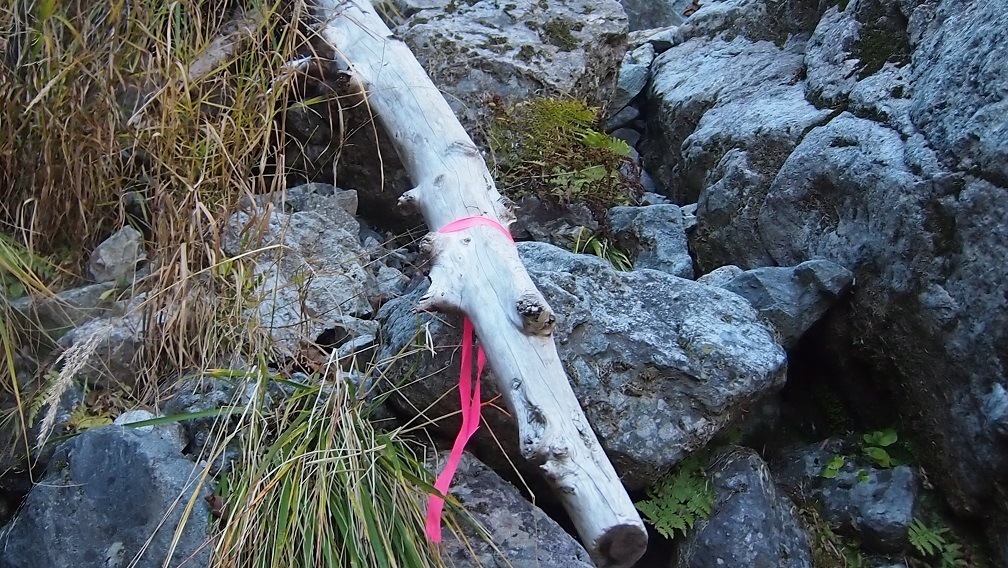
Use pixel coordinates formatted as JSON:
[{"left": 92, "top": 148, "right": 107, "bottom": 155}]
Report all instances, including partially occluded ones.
[{"left": 635, "top": 455, "right": 715, "bottom": 539}]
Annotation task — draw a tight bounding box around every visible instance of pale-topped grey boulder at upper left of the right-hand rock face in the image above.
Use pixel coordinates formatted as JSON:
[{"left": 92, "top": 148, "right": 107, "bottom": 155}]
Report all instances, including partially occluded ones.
[{"left": 641, "top": 36, "right": 831, "bottom": 204}]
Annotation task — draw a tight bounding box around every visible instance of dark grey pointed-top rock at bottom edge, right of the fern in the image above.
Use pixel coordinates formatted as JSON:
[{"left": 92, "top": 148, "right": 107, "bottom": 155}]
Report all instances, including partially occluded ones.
[{"left": 671, "top": 448, "right": 812, "bottom": 568}]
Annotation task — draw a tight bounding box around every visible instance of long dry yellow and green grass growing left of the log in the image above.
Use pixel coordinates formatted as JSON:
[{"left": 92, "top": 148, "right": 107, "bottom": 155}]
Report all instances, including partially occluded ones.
[{"left": 0, "top": 0, "right": 457, "bottom": 566}]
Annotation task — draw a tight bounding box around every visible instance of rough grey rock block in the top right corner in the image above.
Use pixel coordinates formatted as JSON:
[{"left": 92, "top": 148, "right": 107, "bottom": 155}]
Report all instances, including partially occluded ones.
[{"left": 911, "top": 0, "right": 1008, "bottom": 187}]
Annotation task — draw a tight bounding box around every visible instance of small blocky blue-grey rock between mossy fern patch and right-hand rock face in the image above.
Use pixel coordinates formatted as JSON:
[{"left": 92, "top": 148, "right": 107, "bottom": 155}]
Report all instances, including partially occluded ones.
[{"left": 606, "top": 205, "right": 694, "bottom": 279}]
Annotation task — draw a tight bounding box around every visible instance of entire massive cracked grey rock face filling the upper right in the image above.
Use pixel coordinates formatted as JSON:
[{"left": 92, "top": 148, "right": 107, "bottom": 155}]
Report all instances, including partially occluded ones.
[{"left": 639, "top": 0, "right": 1008, "bottom": 556}]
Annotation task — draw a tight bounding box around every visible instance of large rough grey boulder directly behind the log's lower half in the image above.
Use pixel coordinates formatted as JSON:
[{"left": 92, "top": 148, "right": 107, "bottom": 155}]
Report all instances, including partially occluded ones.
[{"left": 379, "top": 243, "right": 785, "bottom": 489}]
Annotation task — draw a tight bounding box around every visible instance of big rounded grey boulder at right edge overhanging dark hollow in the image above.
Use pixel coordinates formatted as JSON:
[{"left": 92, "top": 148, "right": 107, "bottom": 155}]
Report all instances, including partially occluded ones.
[{"left": 760, "top": 115, "right": 1008, "bottom": 512}]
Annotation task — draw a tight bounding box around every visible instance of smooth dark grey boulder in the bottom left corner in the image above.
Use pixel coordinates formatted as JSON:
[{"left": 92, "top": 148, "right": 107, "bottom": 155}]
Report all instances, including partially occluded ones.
[{"left": 0, "top": 426, "right": 213, "bottom": 568}]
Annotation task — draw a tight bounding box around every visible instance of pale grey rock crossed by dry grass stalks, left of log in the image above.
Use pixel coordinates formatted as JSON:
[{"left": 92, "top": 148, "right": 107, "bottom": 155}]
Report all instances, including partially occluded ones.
[{"left": 224, "top": 186, "right": 378, "bottom": 356}]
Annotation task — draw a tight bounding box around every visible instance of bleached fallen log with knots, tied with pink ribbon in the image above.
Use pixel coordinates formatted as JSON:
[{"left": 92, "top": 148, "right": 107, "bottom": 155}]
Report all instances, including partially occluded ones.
[{"left": 316, "top": 0, "right": 647, "bottom": 567}]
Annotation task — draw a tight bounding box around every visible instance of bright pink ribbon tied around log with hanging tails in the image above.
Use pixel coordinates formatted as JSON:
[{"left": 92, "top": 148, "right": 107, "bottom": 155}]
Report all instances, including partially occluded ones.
[{"left": 426, "top": 217, "right": 514, "bottom": 543}]
